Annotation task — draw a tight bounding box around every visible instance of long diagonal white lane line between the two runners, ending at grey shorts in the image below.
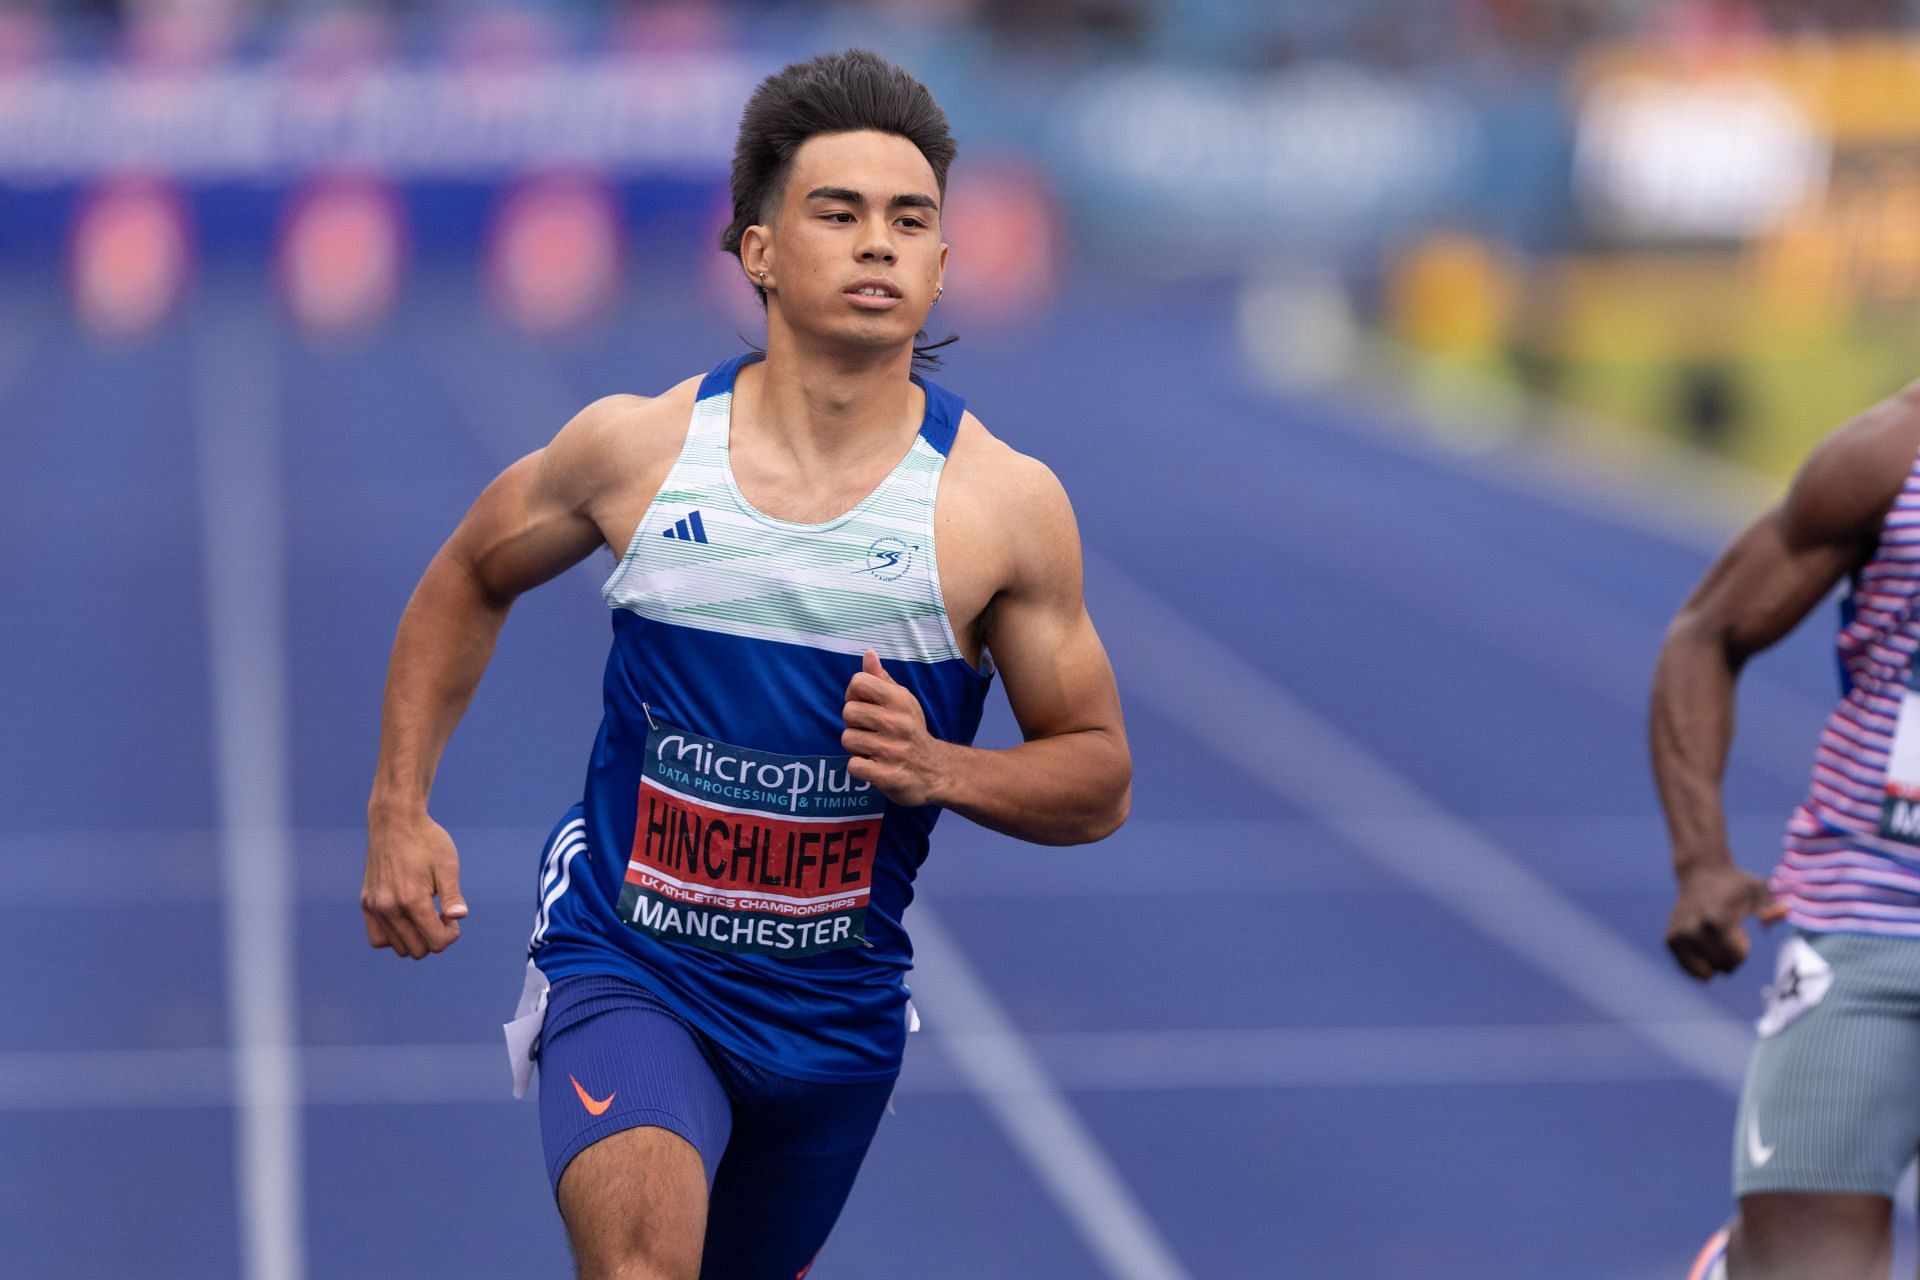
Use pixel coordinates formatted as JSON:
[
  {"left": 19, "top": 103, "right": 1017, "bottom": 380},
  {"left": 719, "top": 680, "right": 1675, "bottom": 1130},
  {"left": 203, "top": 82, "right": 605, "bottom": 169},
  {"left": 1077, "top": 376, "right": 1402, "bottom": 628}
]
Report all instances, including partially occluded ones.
[{"left": 1087, "top": 557, "right": 1753, "bottom": 1092}]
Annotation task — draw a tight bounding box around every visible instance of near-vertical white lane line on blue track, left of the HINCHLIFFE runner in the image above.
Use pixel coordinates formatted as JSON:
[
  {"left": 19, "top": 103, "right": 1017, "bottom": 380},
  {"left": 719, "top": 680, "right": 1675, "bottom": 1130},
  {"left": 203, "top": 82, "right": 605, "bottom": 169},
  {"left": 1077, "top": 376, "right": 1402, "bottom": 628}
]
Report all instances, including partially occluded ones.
[{"left": 194, "top": 290, "right": 303, "bottom": 1280}]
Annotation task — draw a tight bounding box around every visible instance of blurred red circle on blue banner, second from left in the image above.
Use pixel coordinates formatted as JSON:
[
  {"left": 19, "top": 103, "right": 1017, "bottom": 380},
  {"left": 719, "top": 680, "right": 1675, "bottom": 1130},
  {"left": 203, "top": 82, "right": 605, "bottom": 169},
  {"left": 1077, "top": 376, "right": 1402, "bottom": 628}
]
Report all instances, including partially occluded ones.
[{"left": 275, "top": 175, "right": 405, "bottom": 334}]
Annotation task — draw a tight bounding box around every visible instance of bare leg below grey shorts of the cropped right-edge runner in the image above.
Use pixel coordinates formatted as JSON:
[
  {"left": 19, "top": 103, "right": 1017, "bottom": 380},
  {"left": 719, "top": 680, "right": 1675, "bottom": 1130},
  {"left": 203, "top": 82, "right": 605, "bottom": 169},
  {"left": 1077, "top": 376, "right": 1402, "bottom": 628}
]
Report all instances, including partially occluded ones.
[{"left": 1726, "top": 1192, "right": 1891, "bottom": 1280}]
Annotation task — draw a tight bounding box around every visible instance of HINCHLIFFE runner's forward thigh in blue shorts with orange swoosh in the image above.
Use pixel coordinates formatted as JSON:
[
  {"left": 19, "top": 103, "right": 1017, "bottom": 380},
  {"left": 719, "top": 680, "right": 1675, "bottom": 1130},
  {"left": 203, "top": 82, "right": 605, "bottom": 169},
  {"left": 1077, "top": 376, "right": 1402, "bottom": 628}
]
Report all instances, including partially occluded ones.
[{"left": 540, "top": 977, "right": 732, "bottom": 1276}]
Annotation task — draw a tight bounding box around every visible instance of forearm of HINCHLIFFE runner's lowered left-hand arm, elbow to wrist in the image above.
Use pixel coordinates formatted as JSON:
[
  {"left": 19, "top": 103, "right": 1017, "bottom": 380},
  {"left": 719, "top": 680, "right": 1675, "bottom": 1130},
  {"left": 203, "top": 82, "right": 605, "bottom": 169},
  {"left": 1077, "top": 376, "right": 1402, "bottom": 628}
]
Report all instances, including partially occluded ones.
[{"left": 369, "top": 549, "right": 513, "bottom": 818}]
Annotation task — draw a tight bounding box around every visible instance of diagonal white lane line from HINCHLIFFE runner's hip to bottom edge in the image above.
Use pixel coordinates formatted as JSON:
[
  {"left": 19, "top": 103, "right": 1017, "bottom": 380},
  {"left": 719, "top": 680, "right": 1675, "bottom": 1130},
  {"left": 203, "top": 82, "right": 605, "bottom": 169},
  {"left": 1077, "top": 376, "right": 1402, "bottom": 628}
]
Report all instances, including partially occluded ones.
[{"left": 914, "top": 902, "right": 1188, "bottom": 1280}]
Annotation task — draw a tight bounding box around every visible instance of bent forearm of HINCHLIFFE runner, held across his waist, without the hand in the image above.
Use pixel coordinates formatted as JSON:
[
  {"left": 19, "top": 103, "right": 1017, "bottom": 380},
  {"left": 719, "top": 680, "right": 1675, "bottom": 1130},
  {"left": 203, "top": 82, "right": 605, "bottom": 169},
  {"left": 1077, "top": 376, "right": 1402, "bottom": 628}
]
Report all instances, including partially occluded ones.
[{"left": 935, "top": 729, "right": 1133, "bottom": 844}]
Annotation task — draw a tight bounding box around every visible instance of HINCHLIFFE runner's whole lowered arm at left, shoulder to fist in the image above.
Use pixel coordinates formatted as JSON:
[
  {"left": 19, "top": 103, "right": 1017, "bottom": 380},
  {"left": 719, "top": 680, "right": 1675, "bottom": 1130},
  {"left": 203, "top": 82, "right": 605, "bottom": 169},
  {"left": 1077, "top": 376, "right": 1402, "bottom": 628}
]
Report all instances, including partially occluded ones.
[{"left": 361, "top": 397, "right": 634, "bottom": 960}]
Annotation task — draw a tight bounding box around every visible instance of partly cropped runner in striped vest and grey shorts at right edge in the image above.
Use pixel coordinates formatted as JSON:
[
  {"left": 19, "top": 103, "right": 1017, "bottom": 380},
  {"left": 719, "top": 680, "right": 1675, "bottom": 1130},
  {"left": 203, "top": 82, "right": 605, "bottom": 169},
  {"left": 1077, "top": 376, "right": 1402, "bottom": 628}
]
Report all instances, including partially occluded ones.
[{"left": 1653, "top": 384, "right": 1920, "bottom": 1280}]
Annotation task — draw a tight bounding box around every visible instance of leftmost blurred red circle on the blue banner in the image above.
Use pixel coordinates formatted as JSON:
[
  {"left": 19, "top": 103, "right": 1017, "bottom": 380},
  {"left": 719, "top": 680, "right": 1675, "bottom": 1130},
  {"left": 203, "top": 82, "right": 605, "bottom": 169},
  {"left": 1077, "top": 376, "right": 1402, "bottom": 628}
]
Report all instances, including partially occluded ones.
[{"left": 67, "top": 177, "right": 194, "bottom": 338}]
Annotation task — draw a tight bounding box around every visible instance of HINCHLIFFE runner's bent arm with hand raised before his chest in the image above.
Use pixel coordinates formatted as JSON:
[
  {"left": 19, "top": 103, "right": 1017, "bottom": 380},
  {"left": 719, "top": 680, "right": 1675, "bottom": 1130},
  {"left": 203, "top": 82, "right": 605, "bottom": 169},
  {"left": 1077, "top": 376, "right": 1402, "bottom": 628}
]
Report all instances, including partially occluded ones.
[{"left": 843, "top": 459, "right": 1133, "bottom": 844}]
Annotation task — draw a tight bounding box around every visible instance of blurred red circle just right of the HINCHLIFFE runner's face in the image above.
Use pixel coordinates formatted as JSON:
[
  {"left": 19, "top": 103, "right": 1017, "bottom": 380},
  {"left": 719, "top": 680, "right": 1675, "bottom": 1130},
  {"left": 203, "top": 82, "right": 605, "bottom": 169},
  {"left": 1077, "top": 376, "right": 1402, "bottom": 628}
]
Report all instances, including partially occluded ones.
[{"left": 935, "top": 157, "right": 1060, "bottom": 320}]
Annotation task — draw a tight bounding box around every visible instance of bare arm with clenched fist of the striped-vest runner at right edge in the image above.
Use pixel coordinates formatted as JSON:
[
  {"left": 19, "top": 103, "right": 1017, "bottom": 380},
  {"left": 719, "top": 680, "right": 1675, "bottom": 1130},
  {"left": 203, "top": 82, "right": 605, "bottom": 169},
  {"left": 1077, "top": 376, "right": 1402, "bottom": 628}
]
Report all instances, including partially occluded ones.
[{"left": 1649, "top": 391, "right": 1920, "bottom": 979}]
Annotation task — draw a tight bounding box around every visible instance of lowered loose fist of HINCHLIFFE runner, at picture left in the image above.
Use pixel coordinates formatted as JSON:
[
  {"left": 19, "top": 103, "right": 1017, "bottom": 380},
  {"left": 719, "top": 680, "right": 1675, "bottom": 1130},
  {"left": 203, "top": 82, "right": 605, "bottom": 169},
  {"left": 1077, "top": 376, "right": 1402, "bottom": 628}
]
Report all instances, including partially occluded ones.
[{"left": 361, "top": 814, "right": 467, "bottom": 960}]
